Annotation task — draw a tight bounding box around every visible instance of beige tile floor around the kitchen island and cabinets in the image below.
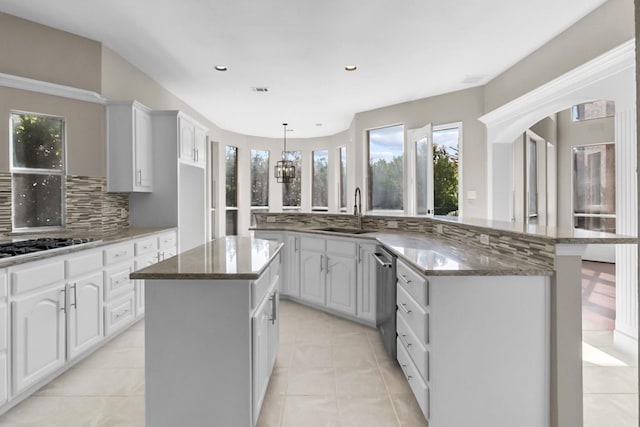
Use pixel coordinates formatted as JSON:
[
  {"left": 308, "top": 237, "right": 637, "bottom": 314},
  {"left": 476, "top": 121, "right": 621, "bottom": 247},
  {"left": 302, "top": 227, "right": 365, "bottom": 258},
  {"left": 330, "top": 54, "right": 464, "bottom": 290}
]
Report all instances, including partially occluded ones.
[{"left": 0, "top": 301, "right": 638, "bottom": 427}]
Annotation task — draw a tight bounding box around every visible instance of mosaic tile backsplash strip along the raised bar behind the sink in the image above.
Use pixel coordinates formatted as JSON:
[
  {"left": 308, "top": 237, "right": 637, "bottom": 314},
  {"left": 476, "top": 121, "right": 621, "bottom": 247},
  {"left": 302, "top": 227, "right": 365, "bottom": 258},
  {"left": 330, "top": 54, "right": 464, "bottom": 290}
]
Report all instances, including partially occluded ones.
[{"left": 256, "top": 213, "right": 555, "bottom": 268}]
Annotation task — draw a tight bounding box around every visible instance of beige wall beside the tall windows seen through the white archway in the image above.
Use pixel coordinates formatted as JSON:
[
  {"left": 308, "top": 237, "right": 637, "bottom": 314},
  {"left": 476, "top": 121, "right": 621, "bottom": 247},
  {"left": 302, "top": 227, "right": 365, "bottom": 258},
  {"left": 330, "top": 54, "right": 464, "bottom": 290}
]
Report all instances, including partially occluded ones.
[{"left": 557, "top": 110, "right": 615, "bottom": 229}]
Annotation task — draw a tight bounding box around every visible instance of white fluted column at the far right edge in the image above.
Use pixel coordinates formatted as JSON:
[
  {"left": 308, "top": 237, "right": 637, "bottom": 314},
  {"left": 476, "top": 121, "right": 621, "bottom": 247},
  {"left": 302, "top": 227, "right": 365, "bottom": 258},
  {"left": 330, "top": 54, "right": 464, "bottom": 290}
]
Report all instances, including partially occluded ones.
[{"left": 614, "top": 105, "right": 638, "bottom": 354}]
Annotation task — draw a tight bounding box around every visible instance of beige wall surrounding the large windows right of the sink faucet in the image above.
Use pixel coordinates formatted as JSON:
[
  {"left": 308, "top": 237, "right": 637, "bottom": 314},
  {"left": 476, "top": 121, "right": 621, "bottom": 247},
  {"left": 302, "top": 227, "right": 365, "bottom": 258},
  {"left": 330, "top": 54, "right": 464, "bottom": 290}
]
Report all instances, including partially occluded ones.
[{"left": 349, "top": 88, "right": 487, "bottom": 218}]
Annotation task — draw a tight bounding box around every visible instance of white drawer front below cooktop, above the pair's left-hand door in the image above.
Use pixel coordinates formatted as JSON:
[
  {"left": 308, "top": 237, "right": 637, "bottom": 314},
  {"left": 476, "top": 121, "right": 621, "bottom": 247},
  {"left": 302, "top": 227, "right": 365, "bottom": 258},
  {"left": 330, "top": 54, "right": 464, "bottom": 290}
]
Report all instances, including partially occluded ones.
[{"left": 9, "top": 258, "right": 64, "bottom": 295}]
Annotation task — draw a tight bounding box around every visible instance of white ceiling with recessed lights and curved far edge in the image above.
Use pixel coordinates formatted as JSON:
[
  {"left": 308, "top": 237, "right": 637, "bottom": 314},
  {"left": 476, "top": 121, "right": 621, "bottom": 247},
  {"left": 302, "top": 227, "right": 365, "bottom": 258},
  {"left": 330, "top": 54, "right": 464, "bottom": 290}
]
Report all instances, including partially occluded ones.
[{"left": 0, "top": 0, "right": 604, "bottom": 138}]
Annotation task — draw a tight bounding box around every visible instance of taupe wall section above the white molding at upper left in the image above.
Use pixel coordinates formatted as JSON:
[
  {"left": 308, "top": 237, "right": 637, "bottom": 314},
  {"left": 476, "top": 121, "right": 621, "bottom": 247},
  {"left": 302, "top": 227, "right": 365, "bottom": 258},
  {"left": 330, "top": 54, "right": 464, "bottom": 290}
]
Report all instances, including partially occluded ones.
[{"left": 0, "top": 13, "right": 101, "bottom": 92}]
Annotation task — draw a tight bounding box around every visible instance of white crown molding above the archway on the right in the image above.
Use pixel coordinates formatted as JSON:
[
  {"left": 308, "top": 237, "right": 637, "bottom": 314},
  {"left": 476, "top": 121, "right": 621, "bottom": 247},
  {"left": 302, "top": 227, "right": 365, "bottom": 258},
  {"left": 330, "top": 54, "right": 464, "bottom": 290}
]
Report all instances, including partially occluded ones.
[{"left": 478, "top": 39, "right": 635, "bottom": 129}]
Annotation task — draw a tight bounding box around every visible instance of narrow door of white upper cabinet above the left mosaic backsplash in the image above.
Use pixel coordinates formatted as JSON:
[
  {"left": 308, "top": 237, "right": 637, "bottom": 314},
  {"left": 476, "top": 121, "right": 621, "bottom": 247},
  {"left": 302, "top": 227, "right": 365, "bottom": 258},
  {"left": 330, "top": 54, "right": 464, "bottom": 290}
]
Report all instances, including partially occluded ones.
[{"left": 133, "top": 108, "right": 153, "bottom": 191}]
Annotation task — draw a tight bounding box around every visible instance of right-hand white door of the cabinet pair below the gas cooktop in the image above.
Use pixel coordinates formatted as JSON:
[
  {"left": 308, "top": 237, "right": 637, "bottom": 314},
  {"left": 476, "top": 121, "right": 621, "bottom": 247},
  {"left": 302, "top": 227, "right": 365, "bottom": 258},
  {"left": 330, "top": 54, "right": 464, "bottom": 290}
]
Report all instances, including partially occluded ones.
[{"left": 67, "top": 272, "right": 104, "bottom": 359}]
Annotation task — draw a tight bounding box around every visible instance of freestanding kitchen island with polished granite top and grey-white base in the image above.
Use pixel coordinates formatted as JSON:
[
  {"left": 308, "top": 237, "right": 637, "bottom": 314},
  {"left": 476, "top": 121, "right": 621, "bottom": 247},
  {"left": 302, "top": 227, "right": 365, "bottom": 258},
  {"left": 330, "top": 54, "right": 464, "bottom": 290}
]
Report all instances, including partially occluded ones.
[{"left": 131, "top": 237, "right": 282, "bottom": 427}]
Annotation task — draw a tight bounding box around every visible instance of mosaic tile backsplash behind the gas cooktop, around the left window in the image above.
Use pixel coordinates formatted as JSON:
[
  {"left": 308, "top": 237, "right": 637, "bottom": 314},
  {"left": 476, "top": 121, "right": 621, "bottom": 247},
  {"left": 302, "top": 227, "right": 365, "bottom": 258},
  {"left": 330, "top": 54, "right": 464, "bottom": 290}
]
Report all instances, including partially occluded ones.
[{"left": 0, "top": 172, "right": 129, "bottom": 233}]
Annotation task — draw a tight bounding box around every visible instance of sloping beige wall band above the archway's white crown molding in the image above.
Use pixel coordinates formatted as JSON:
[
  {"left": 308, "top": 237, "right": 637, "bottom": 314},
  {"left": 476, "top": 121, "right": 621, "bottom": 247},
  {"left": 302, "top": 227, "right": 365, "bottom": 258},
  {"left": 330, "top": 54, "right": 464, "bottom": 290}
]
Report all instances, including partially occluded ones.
[{"left": 485, "top": 0, "right": 635, "bottom": 112}]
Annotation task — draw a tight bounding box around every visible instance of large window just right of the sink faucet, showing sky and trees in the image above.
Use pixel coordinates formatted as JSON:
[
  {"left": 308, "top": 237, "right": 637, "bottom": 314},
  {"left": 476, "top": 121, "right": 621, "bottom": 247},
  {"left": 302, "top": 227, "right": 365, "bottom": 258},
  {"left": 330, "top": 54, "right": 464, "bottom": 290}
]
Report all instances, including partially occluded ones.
[{"left": 368, "top": 125, "right": 404, "bottom": 210}]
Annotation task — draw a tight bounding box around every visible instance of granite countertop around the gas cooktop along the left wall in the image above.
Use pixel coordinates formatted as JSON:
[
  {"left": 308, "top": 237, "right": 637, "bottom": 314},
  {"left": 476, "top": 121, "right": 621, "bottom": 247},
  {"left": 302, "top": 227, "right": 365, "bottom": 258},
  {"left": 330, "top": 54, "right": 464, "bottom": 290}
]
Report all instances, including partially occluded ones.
[{"left": 0, "top": 227, "right": 177, "bottom": 268}]
